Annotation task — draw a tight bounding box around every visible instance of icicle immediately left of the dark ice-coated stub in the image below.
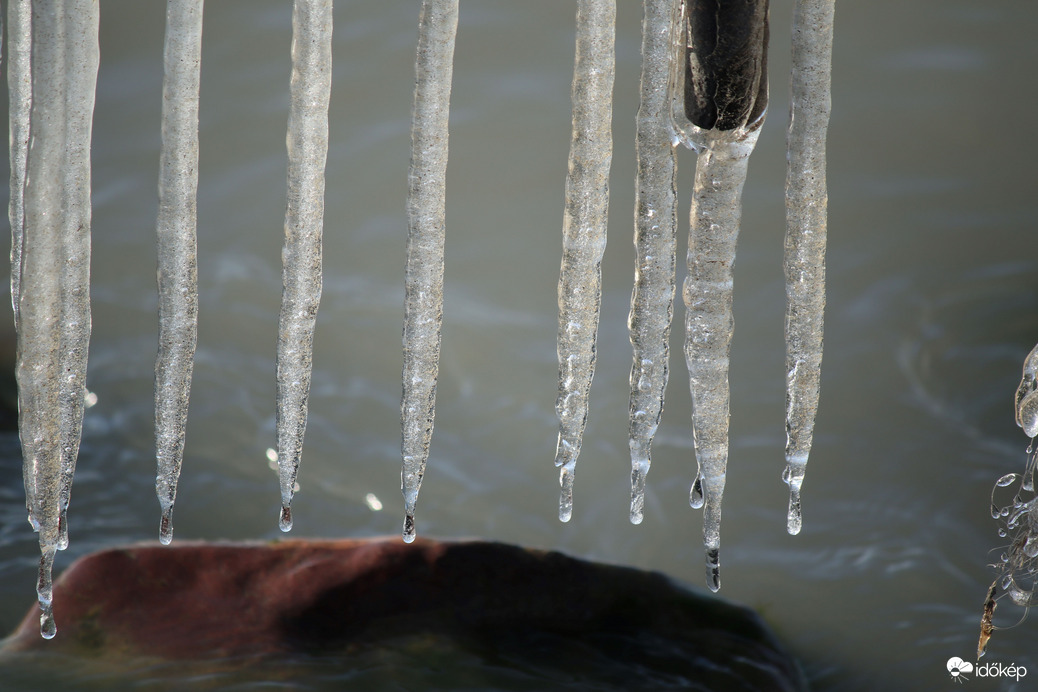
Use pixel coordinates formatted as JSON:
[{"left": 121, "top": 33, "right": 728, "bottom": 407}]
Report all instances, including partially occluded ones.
[{"left": 627, "top": 0, "right": 678, "bottom": 524}]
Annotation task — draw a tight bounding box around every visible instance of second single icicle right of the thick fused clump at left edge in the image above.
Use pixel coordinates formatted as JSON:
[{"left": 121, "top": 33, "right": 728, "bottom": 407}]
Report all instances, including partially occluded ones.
[{"left": 277, "top": 0, "right": 332, "bottom": 531}]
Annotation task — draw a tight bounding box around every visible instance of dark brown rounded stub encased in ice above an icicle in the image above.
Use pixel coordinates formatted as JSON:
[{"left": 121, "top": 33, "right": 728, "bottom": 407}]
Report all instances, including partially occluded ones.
[{"left": 685, "top": 0, "right": 768, "bottom": 131}]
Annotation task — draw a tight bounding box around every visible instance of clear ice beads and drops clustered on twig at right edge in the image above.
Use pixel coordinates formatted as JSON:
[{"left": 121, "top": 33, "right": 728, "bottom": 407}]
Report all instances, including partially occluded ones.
[{"left": 977, "top": 345, "right": 1038, "bottom": 659}]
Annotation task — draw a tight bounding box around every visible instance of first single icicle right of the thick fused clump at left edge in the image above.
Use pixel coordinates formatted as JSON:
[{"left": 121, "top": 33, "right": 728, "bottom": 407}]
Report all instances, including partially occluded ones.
[{"left": 155, "top": 0, "right": 202, "bottom": 545}]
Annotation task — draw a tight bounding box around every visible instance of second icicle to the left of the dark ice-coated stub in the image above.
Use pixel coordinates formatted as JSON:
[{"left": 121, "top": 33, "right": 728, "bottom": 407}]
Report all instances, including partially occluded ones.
[{"left": 555, "top": 0, "right": 617, "bottom": 522}]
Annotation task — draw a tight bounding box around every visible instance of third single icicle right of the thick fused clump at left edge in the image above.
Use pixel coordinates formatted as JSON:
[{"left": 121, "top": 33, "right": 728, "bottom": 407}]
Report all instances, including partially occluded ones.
[{"left": 401, "top": 0, "right": 458, "bottom": 543}]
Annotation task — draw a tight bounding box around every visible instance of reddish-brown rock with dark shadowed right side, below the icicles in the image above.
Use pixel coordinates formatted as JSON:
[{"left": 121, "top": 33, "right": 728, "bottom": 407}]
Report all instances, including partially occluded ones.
[{"left": 0, "top": 538, "right": 805, "bottom": 692}]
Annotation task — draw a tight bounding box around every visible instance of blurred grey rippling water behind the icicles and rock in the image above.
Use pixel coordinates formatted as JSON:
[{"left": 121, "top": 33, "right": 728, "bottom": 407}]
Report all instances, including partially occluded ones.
[{"left": 0, "top": 0, "right": 1038, "bottom": 691}]
